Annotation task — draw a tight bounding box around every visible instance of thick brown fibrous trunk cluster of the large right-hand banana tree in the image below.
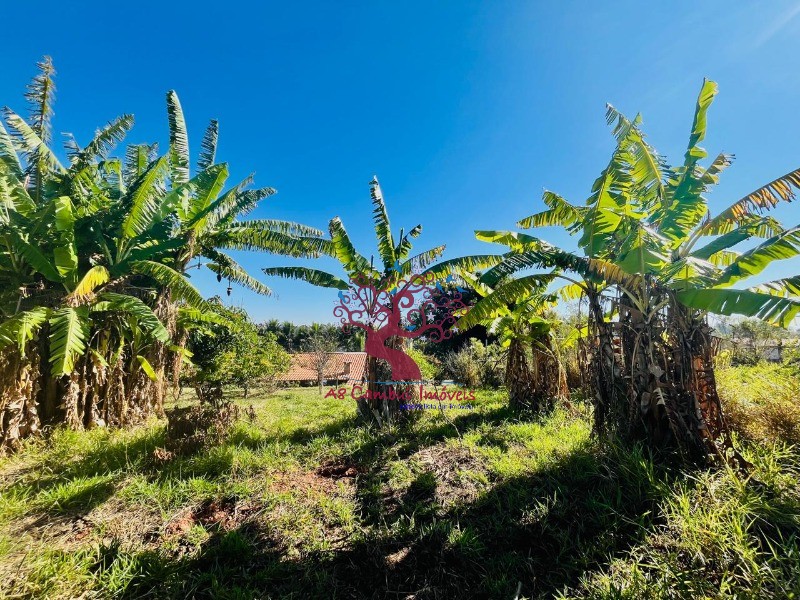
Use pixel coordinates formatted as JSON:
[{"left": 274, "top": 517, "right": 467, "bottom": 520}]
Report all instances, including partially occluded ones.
[{"left": 589, "top": 286, "right": 738, "bottom": 462}]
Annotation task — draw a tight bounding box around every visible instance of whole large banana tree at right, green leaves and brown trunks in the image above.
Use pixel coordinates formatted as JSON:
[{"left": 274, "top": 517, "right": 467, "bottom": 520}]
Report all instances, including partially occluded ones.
[{"left": 485, "top": 81, "right": 800, "bottom": 458}]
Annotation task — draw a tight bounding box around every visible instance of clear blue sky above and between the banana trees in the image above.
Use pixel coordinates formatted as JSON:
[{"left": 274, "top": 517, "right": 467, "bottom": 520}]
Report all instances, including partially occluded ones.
[{"left": 0, "top": 0, "right": 800, "bottom": 322}]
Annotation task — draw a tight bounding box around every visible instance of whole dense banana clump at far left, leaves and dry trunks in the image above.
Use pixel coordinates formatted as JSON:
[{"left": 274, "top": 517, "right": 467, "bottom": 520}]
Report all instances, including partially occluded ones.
[{"left": 0, "top": 59, "right": 320, "bottom": 442}]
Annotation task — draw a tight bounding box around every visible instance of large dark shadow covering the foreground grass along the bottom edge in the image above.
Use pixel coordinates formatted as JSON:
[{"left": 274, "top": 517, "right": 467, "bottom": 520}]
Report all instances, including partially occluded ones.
[{"left": 90, "top": 445, "right": 668, "bottom": 599}]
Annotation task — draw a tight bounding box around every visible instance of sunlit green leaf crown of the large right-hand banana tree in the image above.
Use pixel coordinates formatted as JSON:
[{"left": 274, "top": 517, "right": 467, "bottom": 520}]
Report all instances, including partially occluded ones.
[{"left": 506, "top": 81, "right": 800, "bottom": 318}]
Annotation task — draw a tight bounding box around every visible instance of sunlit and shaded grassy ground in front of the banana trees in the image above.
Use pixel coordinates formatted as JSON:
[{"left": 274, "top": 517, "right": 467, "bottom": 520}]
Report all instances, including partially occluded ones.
[{"left": 0, "top": 370, "right": 800, "bottom": 599}]
